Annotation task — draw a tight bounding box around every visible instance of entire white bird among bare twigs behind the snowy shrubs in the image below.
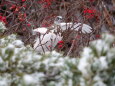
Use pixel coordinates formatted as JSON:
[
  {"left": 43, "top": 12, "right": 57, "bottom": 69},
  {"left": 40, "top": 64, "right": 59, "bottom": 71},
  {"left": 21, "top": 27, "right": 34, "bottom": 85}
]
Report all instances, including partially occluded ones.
[{"left": 33, "top": 16, "right": 92, "bottom": 54}]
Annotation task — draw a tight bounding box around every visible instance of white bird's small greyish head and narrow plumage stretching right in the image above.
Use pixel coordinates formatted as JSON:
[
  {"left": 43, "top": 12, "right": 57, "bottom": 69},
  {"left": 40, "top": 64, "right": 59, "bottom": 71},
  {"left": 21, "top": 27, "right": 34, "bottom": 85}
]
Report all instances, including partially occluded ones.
[{"left": 54, "top": 16, "right": 92, "bottom": 33}]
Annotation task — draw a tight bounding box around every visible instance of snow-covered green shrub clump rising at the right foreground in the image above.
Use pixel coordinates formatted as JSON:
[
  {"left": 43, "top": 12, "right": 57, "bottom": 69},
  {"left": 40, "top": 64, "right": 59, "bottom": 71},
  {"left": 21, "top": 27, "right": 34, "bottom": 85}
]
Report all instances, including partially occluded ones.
[{"left": 78, "top": 34, "right": 115, "bottom": 86}]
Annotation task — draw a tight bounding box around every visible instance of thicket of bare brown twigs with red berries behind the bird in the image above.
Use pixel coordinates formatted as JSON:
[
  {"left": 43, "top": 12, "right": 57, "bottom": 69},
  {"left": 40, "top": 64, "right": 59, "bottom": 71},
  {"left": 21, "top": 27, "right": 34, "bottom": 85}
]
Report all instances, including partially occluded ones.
[{"left": 0, "top": 0, "right": 115, "bottom": 56}]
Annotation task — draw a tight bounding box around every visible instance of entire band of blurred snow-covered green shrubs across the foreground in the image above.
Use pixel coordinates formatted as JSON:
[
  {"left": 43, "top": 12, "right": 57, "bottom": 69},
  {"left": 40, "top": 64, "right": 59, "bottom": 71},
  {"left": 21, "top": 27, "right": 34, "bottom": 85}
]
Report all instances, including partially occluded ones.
[{"left": 0, "top": 22, "right": 115, "bottom": 86}]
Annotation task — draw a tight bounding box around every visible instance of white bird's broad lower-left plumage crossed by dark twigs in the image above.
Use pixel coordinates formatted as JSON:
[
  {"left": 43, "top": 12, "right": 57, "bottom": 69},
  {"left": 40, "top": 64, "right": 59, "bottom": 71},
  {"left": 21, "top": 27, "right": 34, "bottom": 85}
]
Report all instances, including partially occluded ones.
[{"left": 34, "top": 28, "right": 62, "bottom": 54}]
